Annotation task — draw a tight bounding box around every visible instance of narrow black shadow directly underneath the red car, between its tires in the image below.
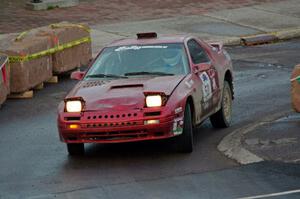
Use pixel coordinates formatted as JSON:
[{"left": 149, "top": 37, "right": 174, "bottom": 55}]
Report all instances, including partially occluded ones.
[{"left": 63, "top": 118, "right": 226, "bottom": 162}]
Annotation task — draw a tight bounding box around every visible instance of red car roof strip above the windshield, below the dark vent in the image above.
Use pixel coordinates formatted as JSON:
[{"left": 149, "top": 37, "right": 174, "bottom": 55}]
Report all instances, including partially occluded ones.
[{"left": 108, "top": 34, "right": 190, "bottom": 47}]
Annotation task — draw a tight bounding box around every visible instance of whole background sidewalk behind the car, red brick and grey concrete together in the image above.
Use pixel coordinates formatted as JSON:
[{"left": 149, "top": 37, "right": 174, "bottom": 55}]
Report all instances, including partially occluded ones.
[{"left": 0, "top": 0, "right": 300, "bottom": 55}]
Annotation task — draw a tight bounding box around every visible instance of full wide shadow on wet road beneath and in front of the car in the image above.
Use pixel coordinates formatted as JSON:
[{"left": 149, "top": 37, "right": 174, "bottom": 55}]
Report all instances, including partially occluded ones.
[{"left": 60, "top": 119, "right": 236, "bottom": 183}]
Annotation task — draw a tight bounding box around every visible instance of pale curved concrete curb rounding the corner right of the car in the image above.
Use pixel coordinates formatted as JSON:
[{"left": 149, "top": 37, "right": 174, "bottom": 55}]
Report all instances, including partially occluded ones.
[{"left": 217, "top": 111, "right": 291, "bottom": 165}]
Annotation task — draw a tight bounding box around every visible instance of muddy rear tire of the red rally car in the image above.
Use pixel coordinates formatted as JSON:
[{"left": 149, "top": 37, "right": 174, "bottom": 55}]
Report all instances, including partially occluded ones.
[{"left": 210, "top": 81, "right": 232, "bottom": 128}]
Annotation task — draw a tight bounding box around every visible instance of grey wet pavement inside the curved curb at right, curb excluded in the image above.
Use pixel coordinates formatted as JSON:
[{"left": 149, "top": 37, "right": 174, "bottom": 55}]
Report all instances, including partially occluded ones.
[{"left": 242, "top": 113, "right": 300, "bottom": 163}]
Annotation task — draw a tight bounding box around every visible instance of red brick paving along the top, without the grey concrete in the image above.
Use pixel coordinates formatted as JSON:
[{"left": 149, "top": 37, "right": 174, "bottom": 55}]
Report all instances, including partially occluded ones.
[{"left": 0, "top": 0, "right": 280, "bottom": 34}]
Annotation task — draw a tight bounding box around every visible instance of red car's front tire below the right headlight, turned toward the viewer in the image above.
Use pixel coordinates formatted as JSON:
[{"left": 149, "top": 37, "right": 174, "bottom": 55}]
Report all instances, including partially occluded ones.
[{"left": 175, "top": 104, "right": 193, "bottom": 153}]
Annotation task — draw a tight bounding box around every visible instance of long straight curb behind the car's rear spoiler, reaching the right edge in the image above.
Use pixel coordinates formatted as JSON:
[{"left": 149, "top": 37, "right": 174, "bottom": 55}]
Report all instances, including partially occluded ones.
[{"left": 222, "top": 27, "right": 300, "bottom": 46}]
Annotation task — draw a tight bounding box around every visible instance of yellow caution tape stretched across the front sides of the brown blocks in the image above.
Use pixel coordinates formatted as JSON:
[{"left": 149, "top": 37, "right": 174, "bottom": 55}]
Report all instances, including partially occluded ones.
[{"left": 9, "top": 37, "right": 91, "bottom": 63}]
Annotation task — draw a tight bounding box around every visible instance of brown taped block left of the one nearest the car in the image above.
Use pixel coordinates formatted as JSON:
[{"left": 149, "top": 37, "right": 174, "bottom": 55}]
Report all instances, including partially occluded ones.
[{"left": 0, "top": 34, "right": 52, "bottom": 93}]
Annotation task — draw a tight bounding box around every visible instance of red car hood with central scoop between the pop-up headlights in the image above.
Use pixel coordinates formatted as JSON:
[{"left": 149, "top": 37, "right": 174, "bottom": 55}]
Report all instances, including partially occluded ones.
[{"left": 67, "top": 75, "right": 185, "bottom": 111}]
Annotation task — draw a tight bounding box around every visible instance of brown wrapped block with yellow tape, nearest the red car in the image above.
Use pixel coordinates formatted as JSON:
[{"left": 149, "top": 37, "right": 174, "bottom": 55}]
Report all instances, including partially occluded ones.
[{"left": 36, "top": 22, "right": 92, "bottom": 74}]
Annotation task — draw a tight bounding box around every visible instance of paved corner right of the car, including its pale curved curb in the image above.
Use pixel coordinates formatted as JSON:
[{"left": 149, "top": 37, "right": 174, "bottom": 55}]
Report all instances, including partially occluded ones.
[{"left": 218, "top": 112, "right": 300, "bottom": 164}]
